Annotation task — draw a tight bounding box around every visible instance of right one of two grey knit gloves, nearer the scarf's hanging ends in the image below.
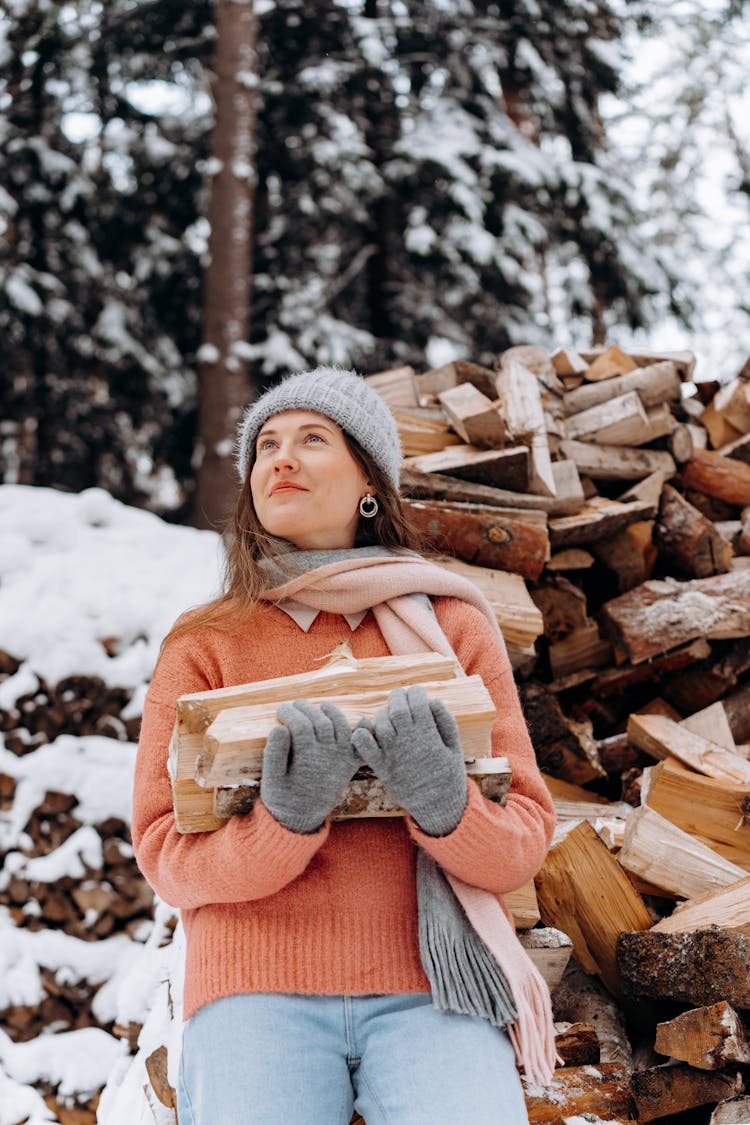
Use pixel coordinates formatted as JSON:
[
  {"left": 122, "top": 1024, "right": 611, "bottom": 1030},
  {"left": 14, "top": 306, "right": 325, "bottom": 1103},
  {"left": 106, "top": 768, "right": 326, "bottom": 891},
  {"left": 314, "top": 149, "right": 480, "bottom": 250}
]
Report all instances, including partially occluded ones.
[{"left": 352, "top": 684, "right": 467, "bottom": 836}]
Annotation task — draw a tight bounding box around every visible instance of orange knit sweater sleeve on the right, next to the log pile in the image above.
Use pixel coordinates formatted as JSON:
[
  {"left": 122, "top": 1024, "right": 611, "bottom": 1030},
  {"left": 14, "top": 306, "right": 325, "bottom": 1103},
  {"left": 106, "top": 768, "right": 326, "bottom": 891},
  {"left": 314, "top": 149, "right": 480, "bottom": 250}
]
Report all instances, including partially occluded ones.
[{"left": 408, "top": 599, "right": 554, "bottom": 894}]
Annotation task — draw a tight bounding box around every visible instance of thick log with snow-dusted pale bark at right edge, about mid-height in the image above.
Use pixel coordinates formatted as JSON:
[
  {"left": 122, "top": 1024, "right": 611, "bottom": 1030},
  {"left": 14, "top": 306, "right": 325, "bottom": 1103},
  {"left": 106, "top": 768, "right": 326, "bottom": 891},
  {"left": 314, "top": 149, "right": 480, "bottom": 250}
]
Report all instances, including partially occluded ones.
[{"left": 602, "top": 571, "right": 750, "bottom": 664}]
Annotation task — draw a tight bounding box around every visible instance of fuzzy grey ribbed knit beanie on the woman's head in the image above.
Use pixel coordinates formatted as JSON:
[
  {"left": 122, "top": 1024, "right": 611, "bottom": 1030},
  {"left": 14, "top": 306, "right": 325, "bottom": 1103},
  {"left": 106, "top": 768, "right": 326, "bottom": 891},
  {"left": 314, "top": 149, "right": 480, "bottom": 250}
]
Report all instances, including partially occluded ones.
[{"left": 237, "top": 367, "right": 401, "bottom": 488}]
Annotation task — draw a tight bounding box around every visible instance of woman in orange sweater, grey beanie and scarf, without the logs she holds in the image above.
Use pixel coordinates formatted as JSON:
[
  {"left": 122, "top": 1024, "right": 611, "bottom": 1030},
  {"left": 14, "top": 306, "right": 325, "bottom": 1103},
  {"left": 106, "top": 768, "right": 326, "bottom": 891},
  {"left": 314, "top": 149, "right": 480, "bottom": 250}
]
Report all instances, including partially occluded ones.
[{"left": 133, "top": 368, "right": 554, "bottom": 1125}]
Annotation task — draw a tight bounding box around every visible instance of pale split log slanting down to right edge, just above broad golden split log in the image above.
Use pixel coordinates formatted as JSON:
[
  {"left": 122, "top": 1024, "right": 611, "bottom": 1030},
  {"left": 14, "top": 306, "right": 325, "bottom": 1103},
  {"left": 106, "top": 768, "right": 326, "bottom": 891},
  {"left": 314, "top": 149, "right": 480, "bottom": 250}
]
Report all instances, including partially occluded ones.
[{"left": 627, "top": 714, "right": 750, "bottom": 786}]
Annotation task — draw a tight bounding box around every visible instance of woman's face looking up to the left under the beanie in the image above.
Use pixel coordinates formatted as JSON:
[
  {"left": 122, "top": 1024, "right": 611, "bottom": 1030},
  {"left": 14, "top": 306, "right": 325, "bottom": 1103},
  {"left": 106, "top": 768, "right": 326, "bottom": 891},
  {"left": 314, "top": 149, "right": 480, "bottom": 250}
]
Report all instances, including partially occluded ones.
[{"left": 250, "top": 411, "right": 371, "bottom": 550}]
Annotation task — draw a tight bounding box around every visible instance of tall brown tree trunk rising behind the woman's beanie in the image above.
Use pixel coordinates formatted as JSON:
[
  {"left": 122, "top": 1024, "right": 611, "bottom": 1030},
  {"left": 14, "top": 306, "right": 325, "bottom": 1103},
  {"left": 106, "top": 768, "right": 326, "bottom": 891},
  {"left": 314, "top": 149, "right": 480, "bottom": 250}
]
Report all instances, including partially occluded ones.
[{"left": 192, "top": 0, "right": 257, "bottom": 528}]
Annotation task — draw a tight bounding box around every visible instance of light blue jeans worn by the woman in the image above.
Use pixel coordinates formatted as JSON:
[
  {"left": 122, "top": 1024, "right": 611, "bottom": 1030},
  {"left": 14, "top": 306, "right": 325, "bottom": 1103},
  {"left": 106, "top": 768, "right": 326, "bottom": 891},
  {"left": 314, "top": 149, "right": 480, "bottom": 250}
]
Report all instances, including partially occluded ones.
[{"left": 178, "top": 992, "right": 528, "bottom": 1125}]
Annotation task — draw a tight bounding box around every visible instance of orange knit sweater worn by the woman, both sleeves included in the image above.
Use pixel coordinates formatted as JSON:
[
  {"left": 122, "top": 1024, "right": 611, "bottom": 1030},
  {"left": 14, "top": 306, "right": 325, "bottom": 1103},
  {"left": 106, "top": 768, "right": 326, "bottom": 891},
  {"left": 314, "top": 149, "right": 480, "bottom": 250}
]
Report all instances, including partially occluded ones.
[{"left": 133, "top": 597, "right": 554, "bottom": 1019}]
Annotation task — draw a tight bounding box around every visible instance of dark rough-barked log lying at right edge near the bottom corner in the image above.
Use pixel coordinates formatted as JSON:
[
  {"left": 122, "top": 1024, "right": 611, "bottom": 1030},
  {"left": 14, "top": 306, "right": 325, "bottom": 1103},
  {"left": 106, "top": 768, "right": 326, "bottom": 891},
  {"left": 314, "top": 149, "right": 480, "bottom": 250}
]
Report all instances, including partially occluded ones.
[{"left": 617, "top": 926, "right": 750, "bottom": 1009}]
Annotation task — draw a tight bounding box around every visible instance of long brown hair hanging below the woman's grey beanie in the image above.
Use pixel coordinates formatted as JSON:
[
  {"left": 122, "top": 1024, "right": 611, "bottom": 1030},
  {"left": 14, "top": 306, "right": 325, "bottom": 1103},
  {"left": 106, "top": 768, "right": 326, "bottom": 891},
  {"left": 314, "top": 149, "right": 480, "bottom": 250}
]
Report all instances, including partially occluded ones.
[{"left": 161, "top": 431, "right": 424, "bottom": 651}]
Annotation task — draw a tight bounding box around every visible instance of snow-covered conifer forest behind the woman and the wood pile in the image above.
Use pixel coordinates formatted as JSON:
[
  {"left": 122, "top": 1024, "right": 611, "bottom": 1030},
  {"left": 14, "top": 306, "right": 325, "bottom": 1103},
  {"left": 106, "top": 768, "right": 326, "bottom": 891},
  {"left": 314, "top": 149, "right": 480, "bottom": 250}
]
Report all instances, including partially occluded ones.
[{"left": 0, "top": 0, "right": 750, "bottom": 527}]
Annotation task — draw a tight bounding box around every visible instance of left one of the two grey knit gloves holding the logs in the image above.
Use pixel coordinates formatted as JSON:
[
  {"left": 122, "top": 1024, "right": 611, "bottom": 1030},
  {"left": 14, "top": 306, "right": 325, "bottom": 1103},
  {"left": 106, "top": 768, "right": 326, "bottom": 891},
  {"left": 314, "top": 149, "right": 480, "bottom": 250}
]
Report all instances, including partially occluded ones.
[{"left": 261, "top": 700, "right": 362, "bottom": 833}]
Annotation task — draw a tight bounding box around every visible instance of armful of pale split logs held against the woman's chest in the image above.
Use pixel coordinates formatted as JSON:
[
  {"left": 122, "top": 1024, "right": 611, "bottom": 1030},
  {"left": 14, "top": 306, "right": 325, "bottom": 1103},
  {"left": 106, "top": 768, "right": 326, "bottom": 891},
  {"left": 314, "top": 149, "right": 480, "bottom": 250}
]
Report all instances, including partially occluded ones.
[{"left": 170, "top": 649, "right": 510, "bottom": 833}]
